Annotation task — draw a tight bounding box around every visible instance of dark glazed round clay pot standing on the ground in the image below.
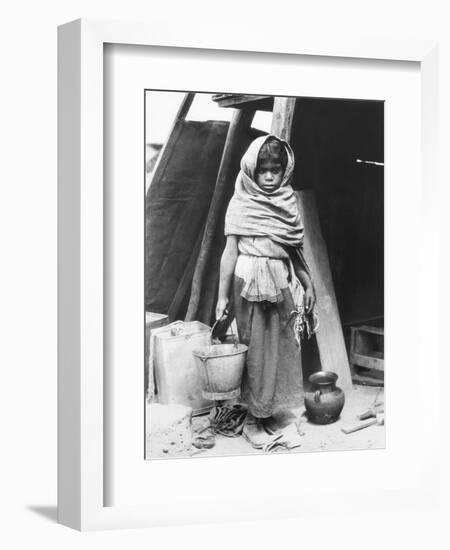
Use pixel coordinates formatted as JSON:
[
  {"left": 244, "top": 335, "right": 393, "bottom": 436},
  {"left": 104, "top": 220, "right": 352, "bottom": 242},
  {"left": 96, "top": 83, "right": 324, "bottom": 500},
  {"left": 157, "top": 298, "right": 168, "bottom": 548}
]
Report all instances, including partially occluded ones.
[{"left": 305, "top": 371, "right": 345, "bottom": 424}]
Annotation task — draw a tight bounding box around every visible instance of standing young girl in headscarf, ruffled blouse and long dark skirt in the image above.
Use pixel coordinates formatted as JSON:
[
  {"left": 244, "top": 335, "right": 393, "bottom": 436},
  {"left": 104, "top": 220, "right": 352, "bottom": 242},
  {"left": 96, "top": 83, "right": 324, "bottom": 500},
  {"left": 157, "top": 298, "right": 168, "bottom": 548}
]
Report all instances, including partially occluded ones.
[{"left": 216, "top": 135, "right": 315, "bottom": 448}]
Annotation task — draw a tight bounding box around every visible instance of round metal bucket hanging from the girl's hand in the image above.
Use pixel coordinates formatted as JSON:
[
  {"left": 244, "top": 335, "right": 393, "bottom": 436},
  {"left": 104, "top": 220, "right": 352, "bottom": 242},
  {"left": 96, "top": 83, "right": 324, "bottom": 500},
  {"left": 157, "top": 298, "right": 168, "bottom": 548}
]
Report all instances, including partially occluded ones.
[{"left": 192, "top": 324, "right": 248, "bottom": 401}]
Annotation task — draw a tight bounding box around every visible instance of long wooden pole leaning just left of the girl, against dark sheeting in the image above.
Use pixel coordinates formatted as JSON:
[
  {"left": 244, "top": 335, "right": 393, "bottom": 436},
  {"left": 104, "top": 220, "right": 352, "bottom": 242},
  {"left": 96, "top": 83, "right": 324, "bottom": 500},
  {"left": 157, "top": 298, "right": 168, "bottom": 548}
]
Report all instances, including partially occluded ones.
[{"left": 186, "top": 109, "right": 255, "bottom": 321}]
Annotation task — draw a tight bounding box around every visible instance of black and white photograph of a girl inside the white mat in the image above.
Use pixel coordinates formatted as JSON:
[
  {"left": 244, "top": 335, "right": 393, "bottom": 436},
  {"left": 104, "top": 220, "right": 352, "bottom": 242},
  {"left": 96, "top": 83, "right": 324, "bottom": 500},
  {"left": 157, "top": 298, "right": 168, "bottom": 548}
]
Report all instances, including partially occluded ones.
[{"left": 143, "top": 90, "right": 385, "bottom": 459}]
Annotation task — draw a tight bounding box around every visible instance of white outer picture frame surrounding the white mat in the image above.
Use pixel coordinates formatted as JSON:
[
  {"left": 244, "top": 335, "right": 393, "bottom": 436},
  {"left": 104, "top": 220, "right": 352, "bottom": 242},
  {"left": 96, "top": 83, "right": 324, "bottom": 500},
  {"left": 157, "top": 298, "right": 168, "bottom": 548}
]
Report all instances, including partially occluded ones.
[{"left": 58, "top": 21, "right": 438, "bottom": 529}]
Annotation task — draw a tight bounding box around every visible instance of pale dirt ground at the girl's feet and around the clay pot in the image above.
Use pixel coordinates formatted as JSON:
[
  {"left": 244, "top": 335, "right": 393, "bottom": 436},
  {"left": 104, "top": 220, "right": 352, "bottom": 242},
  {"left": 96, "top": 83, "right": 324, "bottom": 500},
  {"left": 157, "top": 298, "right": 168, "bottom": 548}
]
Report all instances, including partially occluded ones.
[{"left": 147, "top": 385, "right": 385, "bottom": 459}]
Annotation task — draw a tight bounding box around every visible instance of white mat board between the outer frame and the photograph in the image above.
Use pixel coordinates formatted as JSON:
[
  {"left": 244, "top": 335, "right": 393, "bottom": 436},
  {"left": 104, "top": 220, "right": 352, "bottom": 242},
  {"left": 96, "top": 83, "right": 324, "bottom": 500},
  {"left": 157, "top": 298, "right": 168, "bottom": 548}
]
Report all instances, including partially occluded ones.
[{"left": 104, "top": 45, "right": 422, "bottom": 506}]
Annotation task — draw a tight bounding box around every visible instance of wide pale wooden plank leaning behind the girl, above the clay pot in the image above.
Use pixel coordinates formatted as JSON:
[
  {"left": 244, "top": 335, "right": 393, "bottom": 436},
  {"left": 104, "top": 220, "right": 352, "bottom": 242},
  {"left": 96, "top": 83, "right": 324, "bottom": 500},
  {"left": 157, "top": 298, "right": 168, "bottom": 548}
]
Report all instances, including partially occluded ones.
[{"left": 296, "top": 190, "right": 352, "bottom": 392}]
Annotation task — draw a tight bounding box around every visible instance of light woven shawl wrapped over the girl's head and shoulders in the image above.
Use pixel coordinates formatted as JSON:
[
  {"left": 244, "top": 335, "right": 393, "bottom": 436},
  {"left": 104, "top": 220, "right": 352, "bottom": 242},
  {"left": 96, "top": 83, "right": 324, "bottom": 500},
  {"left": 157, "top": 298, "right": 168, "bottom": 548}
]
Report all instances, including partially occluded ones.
[{"left": 225, "top": 134, "right": 303, "bottom": 247}]
